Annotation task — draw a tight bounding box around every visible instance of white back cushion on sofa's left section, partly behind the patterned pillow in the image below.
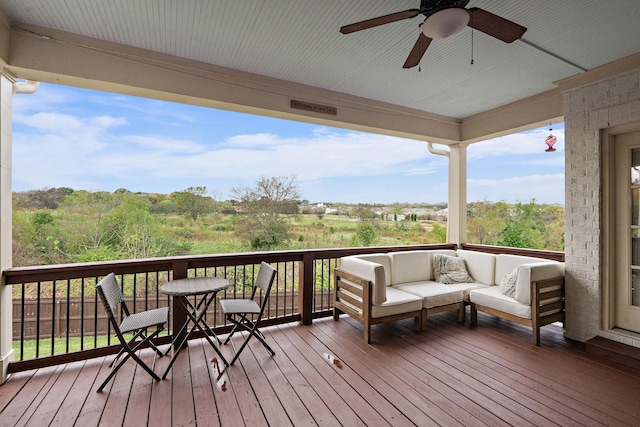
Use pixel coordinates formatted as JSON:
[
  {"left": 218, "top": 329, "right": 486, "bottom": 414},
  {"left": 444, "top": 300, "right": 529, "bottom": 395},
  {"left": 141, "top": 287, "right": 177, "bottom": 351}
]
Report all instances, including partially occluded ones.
[{"left": 389, "top": 249, "right": 456, "bottom": 285}]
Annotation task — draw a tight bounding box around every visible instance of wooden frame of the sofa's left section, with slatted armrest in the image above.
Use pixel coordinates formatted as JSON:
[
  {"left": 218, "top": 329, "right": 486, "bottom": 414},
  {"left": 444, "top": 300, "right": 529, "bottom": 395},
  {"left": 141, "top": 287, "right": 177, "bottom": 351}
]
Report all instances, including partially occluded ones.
[{"left": 333, "top": 268, "right": 465, "bottom": 344}]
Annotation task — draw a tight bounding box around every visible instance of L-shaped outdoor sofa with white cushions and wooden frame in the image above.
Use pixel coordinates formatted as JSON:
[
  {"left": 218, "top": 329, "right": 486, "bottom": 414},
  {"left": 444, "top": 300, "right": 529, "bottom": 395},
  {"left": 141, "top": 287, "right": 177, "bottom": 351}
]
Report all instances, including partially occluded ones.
[{"left": 333, "top": 249, "right": 564, "bottom": 345}]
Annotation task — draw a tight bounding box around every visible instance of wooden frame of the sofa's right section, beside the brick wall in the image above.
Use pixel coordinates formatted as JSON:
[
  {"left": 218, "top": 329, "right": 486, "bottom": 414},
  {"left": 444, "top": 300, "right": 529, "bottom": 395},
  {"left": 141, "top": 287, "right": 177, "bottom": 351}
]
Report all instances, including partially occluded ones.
[{"left": 470, "top": 277, "right": 565, "bottom": 346}]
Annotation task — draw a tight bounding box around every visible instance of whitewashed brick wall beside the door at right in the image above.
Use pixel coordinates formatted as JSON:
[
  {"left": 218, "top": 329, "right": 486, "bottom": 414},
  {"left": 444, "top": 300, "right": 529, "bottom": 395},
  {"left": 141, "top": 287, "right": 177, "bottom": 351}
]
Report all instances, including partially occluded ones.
[{"left": 564, "top": 72, "right": 640, "bottom": 341}]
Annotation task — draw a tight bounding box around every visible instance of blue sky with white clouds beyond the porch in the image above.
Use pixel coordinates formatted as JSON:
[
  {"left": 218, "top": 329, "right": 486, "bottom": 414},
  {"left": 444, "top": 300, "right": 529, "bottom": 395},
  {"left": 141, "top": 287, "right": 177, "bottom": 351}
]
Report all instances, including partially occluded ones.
[{"left": 12, "top": 83, "right": 564, "bottom": 204}]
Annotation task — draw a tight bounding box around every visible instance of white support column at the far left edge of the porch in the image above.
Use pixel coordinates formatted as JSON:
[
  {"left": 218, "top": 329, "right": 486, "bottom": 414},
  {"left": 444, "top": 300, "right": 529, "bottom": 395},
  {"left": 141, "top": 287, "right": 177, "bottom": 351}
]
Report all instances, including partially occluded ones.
[{"left": 0, "top": 73, "right": 15, "bottom": 384}]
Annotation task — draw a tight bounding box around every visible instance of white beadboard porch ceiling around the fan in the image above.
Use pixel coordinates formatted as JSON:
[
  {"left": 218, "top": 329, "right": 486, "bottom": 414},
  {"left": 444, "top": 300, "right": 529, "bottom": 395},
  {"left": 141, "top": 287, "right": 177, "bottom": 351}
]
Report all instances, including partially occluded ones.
[{"left": 0, "top": 0, "right": 640, "bottom": 118}]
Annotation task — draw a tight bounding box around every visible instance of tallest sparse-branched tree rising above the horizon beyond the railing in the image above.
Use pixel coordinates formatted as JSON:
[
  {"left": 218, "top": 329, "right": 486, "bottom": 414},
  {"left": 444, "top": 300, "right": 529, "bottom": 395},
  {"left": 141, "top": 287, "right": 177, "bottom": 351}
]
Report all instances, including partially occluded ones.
[{"left": 232, "top": 175, "right": 300, "bottom": 249}]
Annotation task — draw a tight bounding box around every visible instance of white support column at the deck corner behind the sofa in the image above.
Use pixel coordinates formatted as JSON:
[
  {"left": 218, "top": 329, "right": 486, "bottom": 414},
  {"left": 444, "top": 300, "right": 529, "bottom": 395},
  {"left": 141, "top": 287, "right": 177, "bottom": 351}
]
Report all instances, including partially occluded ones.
[{"left": 447, "top": 144, "right": 467, "bottom": 245}]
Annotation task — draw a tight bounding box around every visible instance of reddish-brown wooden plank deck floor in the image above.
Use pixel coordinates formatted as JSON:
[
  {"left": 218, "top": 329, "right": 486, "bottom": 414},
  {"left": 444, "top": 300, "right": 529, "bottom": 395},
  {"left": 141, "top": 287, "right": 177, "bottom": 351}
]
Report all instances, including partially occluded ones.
[{"left": 0, "top": 313, "right": 640, "bottom": 427}]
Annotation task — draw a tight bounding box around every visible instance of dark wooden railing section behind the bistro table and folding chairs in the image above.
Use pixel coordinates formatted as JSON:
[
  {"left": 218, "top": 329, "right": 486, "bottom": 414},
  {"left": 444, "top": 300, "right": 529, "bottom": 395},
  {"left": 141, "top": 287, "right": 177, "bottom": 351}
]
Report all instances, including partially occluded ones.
[{"left": 4, "top": 244, "right": 455, "bottom": 372}]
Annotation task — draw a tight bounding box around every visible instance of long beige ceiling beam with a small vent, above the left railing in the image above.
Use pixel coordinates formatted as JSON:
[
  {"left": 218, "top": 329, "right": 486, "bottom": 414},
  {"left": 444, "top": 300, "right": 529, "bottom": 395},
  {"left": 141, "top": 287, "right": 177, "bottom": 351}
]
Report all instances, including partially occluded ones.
[{"left": 9, "top": 24, "right": 460, "bottom": 144}]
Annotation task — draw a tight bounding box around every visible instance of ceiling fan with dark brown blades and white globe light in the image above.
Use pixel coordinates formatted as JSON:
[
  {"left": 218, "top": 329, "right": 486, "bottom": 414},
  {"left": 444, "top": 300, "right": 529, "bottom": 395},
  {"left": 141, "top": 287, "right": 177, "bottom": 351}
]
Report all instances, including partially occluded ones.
[{"left": 340, "top": 0, "right": 527, "bottom": 68}]
